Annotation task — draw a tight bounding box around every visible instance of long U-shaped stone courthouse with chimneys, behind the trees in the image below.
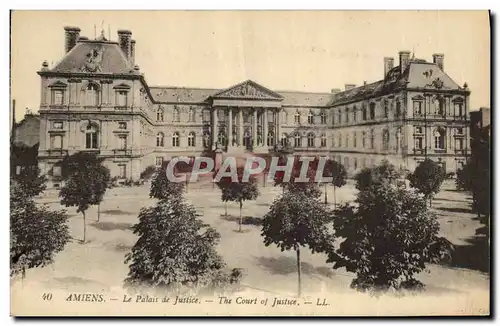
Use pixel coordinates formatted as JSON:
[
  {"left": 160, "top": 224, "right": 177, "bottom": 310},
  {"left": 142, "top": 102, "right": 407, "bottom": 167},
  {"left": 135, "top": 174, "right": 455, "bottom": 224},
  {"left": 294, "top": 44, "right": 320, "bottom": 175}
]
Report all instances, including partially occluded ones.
[{"left": 38, "top": 27, "right": 470, "bottom": 183}]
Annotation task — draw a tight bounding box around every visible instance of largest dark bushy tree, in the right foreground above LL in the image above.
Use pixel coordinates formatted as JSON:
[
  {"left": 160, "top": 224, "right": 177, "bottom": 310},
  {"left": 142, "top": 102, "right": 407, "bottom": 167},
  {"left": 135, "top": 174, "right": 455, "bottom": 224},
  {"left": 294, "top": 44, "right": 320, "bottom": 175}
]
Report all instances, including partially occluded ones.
[{"left": 327, "top": 184, "right": 451, "bottom": 291}]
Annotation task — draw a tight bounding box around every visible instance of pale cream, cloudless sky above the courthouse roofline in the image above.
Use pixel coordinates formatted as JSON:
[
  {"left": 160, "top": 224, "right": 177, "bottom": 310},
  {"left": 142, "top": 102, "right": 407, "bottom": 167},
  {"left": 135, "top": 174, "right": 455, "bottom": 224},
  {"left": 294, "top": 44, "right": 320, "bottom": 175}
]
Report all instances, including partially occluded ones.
[{"left": 11, "top": 11, "right": 490, "bottom": 121}]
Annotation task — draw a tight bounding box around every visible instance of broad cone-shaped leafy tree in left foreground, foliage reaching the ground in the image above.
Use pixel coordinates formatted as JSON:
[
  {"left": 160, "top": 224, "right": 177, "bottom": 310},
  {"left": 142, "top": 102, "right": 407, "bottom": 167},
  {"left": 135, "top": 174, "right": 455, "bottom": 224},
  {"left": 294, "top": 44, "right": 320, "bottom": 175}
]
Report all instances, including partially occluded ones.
[{"left": 125, "top": 196, "right": 241, "bottom": 291}]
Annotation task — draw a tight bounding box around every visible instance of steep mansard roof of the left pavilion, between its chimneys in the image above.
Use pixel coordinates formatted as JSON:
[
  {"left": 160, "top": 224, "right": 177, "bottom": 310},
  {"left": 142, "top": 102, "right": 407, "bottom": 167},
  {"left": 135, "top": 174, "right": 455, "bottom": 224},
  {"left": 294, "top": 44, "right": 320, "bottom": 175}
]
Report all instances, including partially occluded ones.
[{"left": 49, "top": 39, "right": 133, "bottom": 74}]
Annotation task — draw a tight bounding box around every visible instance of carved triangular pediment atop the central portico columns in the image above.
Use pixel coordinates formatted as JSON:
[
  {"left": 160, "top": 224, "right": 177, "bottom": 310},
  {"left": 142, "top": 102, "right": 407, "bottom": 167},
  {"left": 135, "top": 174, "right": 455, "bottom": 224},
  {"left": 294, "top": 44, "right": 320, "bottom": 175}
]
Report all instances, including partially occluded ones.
[{"left": 212, "top": 80, "right": 283, "bottom": 101}]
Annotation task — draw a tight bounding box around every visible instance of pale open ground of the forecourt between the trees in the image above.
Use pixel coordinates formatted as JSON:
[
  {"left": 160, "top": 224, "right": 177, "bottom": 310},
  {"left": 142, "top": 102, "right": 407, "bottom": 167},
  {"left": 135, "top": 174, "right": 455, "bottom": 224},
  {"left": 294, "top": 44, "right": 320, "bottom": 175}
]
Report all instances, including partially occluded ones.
[{"left": 11, "top": 184, "right": 490, "bottom": 314}]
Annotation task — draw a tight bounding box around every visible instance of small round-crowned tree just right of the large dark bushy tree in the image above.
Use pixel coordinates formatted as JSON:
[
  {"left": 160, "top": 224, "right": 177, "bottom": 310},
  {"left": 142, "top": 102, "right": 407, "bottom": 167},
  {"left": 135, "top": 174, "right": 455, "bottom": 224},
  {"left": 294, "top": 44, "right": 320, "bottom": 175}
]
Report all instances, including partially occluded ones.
[{"left": 408, "top": 159, "right": 446, "bottom": 206}]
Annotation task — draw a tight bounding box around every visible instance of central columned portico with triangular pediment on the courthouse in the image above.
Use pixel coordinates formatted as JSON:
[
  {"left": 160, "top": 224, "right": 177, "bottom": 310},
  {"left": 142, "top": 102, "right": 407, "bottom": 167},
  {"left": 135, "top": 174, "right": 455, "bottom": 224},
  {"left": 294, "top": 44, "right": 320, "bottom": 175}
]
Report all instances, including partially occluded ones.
[{"left": 211, "top": 81, "right": 283, "bottom": 153}]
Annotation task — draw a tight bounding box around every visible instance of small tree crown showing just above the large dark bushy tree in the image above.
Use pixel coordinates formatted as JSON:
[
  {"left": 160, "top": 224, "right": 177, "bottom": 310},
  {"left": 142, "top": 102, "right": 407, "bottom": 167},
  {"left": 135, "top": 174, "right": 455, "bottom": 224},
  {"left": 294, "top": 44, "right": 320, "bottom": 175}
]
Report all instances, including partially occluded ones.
[{"left": 354, "top": 160, "right": 401, "bottom": 191}]
